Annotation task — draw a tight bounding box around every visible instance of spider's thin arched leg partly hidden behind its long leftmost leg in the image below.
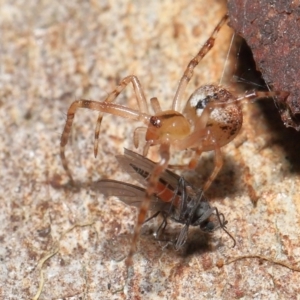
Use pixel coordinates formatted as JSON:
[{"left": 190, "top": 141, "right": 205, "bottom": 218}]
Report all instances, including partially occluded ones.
[{"left": 94, "top": 75, "right": 149, "bottom": 157}]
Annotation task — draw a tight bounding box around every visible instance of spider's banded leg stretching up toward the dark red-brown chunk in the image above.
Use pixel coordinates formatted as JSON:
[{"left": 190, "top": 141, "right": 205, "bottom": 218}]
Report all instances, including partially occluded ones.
[{"left": 172, "top": 15, "right": 228, "bottom": 111}]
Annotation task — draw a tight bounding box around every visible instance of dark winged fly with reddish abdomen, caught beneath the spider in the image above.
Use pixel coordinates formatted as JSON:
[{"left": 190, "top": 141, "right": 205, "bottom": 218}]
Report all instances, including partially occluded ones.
[{"left": 94, "top": 149, "right": 236, "bottom": 250}]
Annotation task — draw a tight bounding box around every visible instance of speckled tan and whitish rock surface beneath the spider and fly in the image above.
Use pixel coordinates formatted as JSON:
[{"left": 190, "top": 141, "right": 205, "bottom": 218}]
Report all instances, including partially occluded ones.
[{"left": 0, "top": 0, "right": 300, "bottom": 300}]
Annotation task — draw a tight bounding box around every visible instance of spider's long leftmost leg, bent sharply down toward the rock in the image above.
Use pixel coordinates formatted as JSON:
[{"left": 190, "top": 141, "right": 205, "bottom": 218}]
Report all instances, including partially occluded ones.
[{"left": 60, "top": 99, "right": 150, "bottom": 182}]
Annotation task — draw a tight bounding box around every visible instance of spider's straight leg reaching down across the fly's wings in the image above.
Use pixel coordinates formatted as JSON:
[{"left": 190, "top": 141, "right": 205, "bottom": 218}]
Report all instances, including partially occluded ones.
[{"left": 125, "top": 143, "right": 170, "bottom": 268}]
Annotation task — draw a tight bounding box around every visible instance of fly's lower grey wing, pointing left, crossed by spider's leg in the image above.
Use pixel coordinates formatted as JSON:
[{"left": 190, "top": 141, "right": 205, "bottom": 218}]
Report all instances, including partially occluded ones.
[{"left": 91, "top": 180, "right": 170, "bottom": 211}]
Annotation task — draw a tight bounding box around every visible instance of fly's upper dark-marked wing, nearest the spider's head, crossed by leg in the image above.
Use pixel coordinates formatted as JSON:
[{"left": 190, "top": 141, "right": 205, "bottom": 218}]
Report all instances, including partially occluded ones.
[{"left": 116, "top": 148, "right": 180, "bottom": 190}]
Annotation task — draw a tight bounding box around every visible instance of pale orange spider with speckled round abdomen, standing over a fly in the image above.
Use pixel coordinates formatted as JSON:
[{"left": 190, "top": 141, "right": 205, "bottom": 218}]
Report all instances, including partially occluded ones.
[{"left": 60, "top": 15, "right": 289, "bottom": 266}]
